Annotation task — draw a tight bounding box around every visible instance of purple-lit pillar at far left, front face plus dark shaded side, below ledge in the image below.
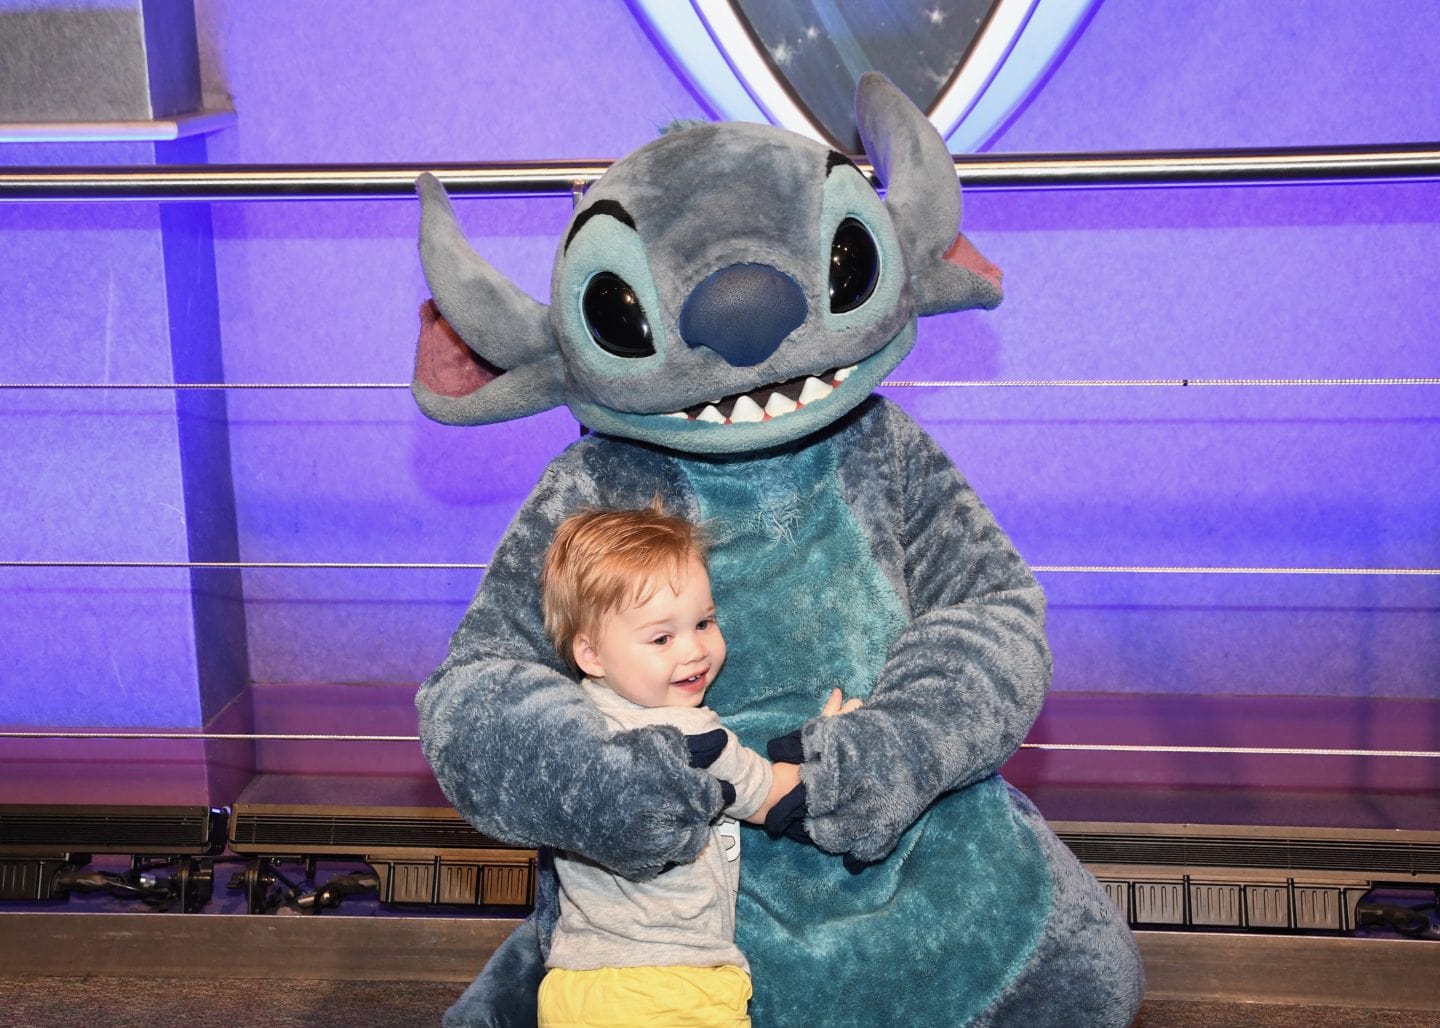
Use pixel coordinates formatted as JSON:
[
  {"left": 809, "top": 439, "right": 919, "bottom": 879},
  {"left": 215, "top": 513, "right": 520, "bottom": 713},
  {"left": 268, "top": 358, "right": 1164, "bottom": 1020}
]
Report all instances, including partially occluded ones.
[{"left": 0, "top": 141, "right": 246, "bottom": 727}]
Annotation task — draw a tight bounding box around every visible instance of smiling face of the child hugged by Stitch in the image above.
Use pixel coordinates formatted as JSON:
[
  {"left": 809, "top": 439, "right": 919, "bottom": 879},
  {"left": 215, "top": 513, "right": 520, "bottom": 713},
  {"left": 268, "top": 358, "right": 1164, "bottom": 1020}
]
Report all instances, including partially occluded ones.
[{"left": 573, "top": 559, "right": 724, "bottom": 707}]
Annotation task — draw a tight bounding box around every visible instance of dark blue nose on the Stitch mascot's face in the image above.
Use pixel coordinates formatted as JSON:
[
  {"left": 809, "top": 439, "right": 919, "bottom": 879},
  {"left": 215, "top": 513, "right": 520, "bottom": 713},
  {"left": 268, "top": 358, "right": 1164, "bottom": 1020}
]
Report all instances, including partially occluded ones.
[{"left": 680, "top": 263, "right": 809, "bottom": 367}]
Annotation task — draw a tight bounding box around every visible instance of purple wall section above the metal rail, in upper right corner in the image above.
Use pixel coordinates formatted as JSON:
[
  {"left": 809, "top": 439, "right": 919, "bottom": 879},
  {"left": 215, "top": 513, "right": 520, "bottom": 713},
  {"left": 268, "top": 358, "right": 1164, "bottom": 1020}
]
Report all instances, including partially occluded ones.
[{"left": 986, "top": 0, "right": 1440, "bottom": 153}]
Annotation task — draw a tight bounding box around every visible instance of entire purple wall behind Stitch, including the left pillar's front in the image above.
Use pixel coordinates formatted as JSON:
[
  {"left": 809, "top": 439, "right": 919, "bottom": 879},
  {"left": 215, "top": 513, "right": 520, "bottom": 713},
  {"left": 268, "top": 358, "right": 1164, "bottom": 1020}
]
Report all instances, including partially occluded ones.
[{"left": 0, "top": 0, "right": 1440, "bottom": 771}]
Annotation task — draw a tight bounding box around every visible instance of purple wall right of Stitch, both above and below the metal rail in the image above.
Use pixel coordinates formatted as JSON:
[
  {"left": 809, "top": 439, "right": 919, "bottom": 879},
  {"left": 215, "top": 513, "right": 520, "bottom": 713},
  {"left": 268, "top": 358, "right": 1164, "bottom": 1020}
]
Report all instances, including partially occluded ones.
[{"left": 956, "top": 0, "right": 1440, "bottom": 698}]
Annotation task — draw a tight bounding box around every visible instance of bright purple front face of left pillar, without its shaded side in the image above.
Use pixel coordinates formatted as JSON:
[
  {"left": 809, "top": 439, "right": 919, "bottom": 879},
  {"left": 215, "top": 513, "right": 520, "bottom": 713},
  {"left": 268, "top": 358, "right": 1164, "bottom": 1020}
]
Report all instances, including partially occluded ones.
[{"left": 0, "top": 145, "right": 200, "bottom": 726}]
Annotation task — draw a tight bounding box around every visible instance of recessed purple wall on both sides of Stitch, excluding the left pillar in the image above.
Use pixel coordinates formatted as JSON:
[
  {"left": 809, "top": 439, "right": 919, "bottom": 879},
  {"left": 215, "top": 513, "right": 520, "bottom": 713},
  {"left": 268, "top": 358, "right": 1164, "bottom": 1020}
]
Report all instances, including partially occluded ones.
[{"left": 197, "top": 0, "right": 1440, "bottom": 695}]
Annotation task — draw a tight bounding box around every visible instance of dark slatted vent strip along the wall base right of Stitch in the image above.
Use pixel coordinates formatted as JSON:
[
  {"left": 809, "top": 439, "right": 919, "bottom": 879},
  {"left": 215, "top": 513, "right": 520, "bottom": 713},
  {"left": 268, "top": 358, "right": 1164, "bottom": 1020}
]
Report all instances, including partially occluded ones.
[{"left": 1060, "top": 832, "right": 1440, "bottom": 874}]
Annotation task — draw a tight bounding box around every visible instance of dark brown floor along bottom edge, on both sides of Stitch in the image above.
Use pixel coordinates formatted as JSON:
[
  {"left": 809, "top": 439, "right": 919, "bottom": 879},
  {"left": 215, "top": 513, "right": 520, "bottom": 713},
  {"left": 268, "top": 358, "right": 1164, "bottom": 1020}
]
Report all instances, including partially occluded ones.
[{"left": 0, "top": 979, "right": 1440, "bottom": 1028}]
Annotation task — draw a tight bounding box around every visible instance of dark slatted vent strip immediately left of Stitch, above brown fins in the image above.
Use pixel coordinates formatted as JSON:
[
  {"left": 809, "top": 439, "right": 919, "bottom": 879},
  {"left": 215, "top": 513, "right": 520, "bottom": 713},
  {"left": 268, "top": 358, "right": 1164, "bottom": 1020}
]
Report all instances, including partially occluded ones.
[{"left": 232, "top": 813, "right": 508, "bottom": 852}]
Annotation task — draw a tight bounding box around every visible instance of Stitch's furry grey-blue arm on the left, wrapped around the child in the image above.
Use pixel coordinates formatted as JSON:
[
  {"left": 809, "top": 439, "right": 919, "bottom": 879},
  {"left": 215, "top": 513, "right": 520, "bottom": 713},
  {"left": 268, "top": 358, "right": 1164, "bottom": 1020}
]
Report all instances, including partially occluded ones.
[{"left": 416, "top": 451, "right": 723, "bottom": 880}]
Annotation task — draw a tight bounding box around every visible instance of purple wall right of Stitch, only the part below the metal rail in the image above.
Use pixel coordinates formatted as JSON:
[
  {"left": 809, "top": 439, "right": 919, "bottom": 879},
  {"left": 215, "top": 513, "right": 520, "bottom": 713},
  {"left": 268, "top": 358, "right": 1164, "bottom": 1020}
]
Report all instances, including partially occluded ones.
[{"left": 891, "top": 183, "right": 1440, "bottom": 698}]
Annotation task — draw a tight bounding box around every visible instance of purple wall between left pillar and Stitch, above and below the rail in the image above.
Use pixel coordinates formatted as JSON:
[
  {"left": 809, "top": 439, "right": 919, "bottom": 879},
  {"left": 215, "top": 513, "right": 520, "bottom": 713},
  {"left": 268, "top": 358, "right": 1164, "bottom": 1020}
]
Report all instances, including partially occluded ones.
[{"left": 200, "top": 1, "right": 704, "bottom": 682}]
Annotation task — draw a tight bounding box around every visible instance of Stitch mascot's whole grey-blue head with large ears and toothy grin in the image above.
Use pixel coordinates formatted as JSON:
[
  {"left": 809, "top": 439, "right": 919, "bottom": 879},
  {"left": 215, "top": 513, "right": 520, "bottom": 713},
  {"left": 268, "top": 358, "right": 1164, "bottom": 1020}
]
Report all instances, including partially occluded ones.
[{"left": 413, "top": 75, "right": 1001, "bottom": 454}]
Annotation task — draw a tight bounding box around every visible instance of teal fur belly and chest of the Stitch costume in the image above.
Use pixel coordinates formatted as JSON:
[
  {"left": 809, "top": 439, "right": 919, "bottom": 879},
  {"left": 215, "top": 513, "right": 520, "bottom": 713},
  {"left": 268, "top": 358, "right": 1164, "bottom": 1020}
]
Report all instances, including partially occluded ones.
[{"left": 681, "top": 445, "right": 1051, "bottom": 1027}]
